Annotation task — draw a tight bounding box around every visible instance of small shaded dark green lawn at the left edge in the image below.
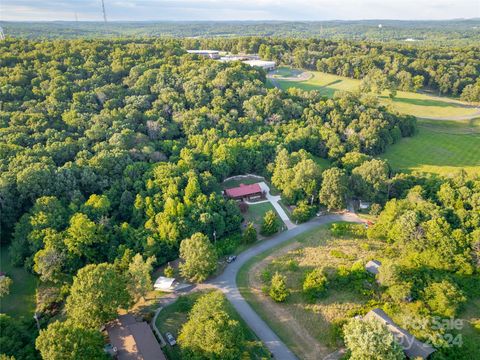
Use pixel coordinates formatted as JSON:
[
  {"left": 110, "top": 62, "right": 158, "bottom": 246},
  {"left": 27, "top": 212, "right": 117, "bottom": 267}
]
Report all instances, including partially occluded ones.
[{"left": 0, "top": 246, "right": 38, "bottom": 317}]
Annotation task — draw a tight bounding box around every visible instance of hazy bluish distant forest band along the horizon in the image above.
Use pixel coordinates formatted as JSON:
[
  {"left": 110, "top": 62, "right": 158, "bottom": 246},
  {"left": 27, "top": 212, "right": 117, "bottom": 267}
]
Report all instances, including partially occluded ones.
[{"left": 0, "top": 19, "right": 480, "bottom": 45}]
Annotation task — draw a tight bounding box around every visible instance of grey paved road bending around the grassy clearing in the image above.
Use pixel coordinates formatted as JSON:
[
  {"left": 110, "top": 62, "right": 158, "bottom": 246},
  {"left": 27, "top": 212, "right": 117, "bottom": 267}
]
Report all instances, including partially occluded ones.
[{"left": 207, "top": 214, "right": 362, "bottom": 360}]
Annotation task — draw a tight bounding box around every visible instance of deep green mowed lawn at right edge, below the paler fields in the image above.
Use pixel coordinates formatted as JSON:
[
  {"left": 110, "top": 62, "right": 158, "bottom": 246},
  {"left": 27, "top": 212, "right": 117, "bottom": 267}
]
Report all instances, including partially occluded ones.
[{"left": 382, "top": 120, "right": 480, "bottom": 175}]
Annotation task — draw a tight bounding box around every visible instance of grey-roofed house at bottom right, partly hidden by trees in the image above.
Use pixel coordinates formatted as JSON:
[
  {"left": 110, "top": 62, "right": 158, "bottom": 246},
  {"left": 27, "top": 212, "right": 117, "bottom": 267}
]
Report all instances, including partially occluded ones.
[{"left": 364, "top": 308, "right": 435, "bottom": 359}]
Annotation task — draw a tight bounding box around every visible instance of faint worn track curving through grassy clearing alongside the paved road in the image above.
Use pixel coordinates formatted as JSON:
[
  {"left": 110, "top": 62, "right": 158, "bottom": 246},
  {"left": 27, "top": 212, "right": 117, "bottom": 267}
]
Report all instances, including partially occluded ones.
[{"left": 248, "top": 242, "right": 329, "bottom": 360}]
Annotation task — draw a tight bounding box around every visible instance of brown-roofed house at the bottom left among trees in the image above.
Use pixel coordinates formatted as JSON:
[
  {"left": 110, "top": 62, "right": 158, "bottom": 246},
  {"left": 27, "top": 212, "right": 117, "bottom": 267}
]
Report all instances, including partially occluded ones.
[{"left": 106, "top": 314, "right": 166, "bottom": 360}]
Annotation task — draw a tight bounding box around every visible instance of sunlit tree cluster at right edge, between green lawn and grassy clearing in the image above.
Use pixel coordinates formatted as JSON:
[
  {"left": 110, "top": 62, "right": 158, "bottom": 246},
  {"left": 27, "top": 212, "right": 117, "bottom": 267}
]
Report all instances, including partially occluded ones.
[{"left": 368, "top": 172, "right": 480, "bottom": 359}]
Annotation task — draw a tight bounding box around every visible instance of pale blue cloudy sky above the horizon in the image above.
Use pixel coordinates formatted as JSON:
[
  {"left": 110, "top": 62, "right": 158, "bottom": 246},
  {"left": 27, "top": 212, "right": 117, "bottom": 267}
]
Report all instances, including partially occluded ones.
[{"left": 0, "top": 0, "right": 480, "bottom": 21}]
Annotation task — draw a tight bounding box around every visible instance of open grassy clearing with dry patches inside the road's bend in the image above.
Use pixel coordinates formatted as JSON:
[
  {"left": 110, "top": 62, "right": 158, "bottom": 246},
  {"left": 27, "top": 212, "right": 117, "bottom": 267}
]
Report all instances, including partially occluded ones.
[{"left": 237, "top": 226, "right": 384, "bottom": 359}]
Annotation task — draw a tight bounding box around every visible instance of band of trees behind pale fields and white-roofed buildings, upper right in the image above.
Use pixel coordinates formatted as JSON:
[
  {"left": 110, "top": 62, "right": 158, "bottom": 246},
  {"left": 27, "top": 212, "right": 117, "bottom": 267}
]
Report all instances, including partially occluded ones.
[{"left": 184, "top": 37, "right": 480, "bottom": 102}]
